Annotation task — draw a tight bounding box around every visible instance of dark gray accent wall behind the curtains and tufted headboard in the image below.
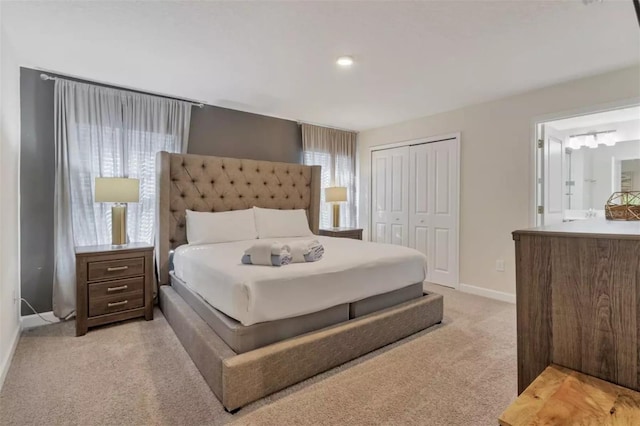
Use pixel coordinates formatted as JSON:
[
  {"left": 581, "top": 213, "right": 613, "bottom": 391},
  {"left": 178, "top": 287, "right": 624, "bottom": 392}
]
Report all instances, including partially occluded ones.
[{"left": 20, "top": 68, "right": 302, "bottom": 315}]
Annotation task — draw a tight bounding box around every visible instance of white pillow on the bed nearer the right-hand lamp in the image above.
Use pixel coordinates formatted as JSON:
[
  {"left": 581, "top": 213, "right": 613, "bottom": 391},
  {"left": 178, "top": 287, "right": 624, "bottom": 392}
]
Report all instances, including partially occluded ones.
[{"left": 253, "top": 207, "right": 313, "bottom": 238}]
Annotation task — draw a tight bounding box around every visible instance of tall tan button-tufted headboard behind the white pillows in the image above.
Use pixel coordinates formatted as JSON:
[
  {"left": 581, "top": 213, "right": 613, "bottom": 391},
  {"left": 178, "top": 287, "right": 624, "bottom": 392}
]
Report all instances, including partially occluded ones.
[{"left": 155, "top": 151, "right": 320, "bottom": 285}]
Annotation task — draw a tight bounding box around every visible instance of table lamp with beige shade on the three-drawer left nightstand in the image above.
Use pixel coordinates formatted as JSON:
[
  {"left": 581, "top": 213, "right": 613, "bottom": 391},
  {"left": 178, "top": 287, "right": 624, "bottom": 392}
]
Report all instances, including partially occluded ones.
[{"left": 95, "top": 178, "right": 140, "bottom": 247}]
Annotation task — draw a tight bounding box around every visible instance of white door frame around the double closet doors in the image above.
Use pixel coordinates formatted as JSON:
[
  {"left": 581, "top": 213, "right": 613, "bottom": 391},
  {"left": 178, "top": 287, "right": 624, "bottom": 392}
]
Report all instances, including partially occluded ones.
[{"left": 367, "top": 132, "right": 462, "bottom": 290}]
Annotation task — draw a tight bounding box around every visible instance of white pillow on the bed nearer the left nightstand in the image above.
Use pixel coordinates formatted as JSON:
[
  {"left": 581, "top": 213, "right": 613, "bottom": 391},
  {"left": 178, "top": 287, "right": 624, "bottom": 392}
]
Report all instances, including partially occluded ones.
[{"left": 187, "top": 209, "right": 258, "bottom": 244}]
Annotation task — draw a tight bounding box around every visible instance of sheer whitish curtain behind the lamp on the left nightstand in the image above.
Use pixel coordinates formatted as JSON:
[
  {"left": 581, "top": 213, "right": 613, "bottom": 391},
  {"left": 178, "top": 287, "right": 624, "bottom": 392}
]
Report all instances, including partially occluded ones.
[{"left": 53, "top": 79, "right": 191, "bottom": 318}]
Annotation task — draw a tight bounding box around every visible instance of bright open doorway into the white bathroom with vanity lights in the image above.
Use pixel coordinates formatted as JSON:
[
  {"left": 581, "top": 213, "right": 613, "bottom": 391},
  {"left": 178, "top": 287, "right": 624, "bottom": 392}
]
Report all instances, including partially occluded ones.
[{"left": 535, "top": 105, "right": 640, "bottom": 226}]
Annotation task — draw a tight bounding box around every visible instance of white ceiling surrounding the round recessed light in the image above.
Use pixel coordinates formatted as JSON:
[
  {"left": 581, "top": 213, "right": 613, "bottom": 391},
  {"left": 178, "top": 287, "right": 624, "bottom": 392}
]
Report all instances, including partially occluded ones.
[{"left": 1, "top": 0, "right": 640, "bottom": 130}]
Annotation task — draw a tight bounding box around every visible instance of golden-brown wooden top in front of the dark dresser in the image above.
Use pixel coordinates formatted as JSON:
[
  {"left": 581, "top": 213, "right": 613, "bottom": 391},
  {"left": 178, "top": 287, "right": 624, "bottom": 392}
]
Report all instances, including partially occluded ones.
[{"left": 498, "top": 365, "right": 640, "bottom": 426}]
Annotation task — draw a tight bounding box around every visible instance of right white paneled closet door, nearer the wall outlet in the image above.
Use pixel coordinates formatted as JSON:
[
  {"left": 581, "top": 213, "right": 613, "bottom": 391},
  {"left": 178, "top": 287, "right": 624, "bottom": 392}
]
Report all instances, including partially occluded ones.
[{"left": 409, "top": 139, "right": 459, "bottom": 287}]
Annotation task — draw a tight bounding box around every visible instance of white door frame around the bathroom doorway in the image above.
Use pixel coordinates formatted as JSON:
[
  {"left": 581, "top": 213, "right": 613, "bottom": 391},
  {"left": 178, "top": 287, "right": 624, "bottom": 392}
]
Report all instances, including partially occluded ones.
[{"left": 529, "top": 97, "right": 640, "bottom": 227}]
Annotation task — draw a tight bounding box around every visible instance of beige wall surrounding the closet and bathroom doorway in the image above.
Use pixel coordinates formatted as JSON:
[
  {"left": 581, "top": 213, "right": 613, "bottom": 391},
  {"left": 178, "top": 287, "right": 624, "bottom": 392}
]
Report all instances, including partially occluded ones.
[{"left": 358, "top": 65, "right": 640, "bottom": 294}]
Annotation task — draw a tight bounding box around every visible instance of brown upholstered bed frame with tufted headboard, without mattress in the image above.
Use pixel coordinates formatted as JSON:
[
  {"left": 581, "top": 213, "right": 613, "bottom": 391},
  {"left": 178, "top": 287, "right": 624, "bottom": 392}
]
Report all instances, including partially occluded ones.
[{"left": 155, "top": 152, "right": 443, "bottom": 411}]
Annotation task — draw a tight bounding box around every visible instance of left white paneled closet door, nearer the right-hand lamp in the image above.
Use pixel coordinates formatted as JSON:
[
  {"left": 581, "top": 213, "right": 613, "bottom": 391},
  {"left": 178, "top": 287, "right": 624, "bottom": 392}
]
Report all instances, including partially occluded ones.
[{"left": 371, "top": 147, "right": 409, "bottom": 246}]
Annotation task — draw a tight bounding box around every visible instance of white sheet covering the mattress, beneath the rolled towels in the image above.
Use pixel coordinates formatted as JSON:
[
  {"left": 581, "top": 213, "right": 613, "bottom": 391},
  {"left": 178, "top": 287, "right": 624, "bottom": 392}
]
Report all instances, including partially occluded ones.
[{"left": 173, "top": 236, "right": 426, "bottom": 325}]
